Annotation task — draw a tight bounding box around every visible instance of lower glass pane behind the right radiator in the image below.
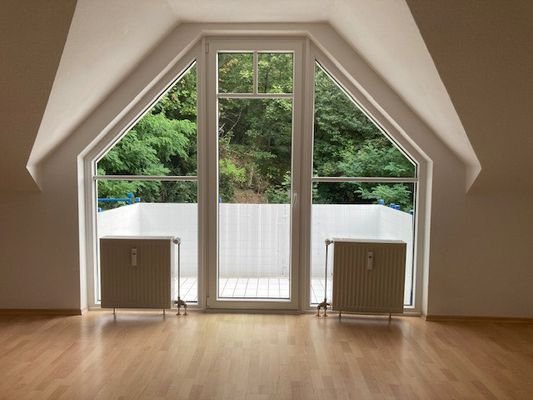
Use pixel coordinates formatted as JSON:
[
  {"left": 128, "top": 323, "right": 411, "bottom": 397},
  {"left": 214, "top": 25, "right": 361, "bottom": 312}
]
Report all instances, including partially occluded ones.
[{"left": 311, "top": 182, "right": 415, "bottom": 305}]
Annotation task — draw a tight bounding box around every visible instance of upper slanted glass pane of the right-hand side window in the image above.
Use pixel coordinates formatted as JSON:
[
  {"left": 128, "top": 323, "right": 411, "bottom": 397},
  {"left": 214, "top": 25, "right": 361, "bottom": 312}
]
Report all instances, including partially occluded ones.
[{"left": 313, "top": 64, "right": 415, "bottom": 177}]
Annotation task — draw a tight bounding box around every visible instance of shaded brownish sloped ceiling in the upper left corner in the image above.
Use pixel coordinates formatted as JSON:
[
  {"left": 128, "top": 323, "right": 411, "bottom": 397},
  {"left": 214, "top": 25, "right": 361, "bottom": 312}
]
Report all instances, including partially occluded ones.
[{"left": 0, "top": 0, "right": 76, "bottom": 191}]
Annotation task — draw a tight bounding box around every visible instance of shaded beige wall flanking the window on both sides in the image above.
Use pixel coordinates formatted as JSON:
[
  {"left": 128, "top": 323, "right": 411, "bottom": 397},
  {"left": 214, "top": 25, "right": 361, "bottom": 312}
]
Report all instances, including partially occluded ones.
[{"left": 0, "top": 21, "right": 533, "bottom": 317}]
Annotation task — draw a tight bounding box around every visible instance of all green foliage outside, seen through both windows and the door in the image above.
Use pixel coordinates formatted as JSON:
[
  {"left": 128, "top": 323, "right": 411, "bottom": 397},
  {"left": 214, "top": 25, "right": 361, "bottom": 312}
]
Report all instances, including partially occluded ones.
[{"left": 98, "top": 57, "right": 415, "bottom": 211}]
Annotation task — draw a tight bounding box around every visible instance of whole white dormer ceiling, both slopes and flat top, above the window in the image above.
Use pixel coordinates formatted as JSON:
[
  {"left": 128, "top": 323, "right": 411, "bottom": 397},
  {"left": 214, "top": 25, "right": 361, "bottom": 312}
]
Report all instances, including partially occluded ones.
[{"left": 28, "top": 0, "right": 481, "bottom": 188}]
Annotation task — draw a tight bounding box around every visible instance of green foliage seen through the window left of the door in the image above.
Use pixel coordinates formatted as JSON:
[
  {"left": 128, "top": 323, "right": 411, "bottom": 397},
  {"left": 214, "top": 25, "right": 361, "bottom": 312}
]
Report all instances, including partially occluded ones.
[{"left": 98, "top": 67, "right": 197, "bottom": 208}]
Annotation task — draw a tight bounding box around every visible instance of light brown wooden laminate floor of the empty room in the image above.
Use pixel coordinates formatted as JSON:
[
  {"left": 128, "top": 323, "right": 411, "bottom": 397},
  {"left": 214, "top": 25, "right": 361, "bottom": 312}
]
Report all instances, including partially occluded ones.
[{"left": 0, "top": 311, "right": 533, "bottom": 400}]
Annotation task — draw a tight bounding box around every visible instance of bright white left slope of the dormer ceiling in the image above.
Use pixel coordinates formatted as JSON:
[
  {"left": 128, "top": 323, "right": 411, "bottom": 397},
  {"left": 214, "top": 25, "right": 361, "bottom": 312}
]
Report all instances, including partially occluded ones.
[{"left": 29, "top": 0, "right": 177, "bottom": 164}]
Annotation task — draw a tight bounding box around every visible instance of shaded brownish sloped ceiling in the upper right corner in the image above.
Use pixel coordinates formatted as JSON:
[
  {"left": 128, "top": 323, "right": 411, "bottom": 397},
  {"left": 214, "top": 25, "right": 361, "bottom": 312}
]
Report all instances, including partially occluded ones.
[{"left": 408, "top": 0, "right": 533, "bottom": 192}]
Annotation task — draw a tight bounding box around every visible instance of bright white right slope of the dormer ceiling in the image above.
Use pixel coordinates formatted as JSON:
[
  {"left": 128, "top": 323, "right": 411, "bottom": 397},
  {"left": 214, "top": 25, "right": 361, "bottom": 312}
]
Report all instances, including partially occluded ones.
[{"left": 330, "top": 0, "right": 481, "bottom": 186}]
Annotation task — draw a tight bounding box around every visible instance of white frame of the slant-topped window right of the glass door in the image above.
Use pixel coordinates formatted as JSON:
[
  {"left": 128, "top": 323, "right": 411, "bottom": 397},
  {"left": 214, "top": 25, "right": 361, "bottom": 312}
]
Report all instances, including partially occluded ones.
[{"left": 302, "top": 41, "right": 429, "bottom": 315}]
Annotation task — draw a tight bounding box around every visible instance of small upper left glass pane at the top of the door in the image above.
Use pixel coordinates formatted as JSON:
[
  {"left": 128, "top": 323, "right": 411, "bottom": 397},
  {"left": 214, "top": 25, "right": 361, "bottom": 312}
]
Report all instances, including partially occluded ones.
[{"left": 218, "top": 53, "right": 254, "bottom": 93}]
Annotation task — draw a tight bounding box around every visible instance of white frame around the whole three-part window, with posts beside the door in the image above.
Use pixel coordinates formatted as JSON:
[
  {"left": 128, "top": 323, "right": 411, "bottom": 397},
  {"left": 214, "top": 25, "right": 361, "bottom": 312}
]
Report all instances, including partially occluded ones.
[{"left": 80, "top": 28, "right": 431, "bottom": 313}]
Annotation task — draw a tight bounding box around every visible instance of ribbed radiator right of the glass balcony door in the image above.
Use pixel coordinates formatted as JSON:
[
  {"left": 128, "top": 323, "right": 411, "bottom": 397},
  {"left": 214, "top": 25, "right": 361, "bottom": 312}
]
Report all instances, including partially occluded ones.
[{"left": 332, "top": 239, "right": 406, "bottom": 316}]
